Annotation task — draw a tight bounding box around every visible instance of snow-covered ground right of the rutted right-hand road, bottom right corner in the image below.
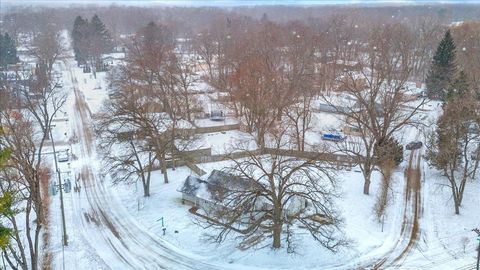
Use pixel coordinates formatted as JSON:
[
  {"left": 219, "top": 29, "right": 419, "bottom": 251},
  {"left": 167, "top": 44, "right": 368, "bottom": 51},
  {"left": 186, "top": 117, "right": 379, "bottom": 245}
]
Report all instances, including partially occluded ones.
[{"left": 417, "top": 166, "right": 480, "bottom": 269}]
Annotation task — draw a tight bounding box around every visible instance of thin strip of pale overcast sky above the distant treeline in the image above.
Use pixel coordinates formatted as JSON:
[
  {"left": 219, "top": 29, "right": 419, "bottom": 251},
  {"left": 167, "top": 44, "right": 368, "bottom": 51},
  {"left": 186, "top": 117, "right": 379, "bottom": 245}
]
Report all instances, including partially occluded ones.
[{"left": 0, "top": 0, "right": 480, "bottom": 6}]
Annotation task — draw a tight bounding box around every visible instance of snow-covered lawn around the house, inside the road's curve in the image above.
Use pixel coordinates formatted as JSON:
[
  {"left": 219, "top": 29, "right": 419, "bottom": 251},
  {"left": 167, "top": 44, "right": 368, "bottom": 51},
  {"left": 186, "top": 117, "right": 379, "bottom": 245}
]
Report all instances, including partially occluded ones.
[{"left": 114, "top": 161, "right": 402, "bottom": 269}]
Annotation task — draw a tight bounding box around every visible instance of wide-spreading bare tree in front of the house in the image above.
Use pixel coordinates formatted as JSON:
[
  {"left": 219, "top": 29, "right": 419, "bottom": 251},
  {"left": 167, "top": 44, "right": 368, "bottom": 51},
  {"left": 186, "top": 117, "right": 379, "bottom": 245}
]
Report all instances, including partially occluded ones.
[{"left": 200, "top": 131, "right": 345, "bottom": 251}]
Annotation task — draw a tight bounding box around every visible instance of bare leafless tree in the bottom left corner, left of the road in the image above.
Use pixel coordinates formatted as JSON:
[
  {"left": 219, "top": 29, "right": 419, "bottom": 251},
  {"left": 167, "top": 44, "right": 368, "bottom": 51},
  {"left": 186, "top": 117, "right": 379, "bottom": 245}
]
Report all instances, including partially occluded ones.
[{"left": 0, "top": 110, "right": 48, "bottom": 270}]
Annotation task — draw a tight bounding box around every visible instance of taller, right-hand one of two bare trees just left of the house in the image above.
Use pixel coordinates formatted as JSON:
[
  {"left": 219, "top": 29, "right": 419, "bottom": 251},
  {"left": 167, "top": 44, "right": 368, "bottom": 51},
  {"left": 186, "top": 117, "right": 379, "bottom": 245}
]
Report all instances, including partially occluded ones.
[{"left": 114, "top": 22, "right": 176, "bottom": 183}]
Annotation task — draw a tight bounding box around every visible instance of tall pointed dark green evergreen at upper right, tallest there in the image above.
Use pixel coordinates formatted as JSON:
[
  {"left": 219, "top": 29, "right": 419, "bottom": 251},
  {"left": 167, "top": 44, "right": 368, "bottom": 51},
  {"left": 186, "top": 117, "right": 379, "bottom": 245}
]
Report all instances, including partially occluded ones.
[{"left": 426, "top": 30, "right": 456, "bottom": 100}]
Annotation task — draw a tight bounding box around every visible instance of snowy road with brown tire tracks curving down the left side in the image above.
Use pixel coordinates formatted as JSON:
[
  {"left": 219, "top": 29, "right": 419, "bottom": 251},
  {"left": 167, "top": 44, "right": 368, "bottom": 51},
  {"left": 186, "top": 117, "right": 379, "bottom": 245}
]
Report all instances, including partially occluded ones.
[{"left": 65, "top": 60, "right": 229, "bottom": 269}]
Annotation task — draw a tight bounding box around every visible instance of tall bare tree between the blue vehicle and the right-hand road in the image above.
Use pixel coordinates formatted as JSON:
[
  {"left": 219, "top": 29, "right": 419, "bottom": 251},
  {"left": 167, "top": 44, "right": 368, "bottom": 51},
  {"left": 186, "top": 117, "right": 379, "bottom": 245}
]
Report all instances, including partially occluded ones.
[{"left": 323, "top": 22, "right": 425, "bottom": 194}]
